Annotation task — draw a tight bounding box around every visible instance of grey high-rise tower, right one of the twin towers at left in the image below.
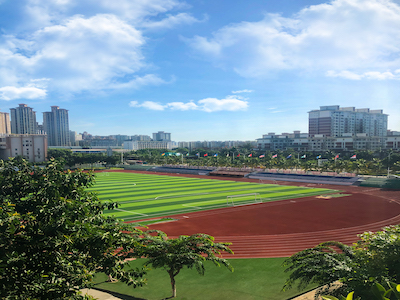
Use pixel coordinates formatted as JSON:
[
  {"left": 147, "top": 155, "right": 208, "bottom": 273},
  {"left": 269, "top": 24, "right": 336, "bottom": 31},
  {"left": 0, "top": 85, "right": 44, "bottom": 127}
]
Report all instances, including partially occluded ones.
[{"left": 43, "top": 106, "right": 70, "bottom": 146}]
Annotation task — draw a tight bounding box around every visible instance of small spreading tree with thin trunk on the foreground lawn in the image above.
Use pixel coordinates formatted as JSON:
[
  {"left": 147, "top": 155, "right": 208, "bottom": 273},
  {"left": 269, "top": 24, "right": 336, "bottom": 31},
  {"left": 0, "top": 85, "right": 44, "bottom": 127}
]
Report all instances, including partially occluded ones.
[{"left": 142, "top": 230, "right": 233, "bottom": 298}]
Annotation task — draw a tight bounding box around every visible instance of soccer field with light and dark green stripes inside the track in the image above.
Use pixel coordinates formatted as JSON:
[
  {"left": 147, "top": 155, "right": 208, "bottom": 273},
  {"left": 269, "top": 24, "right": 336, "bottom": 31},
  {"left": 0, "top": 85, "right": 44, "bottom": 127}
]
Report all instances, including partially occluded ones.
[{"left": 89, "top": 172, "right": 337, "bottom": 221}]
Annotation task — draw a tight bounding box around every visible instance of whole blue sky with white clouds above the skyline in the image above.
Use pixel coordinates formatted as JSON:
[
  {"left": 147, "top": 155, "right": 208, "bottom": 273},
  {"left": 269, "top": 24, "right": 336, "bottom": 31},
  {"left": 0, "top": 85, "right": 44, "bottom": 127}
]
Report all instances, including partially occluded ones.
[{"left": 0, "top": 0, "right": 400, "bottom": 141}]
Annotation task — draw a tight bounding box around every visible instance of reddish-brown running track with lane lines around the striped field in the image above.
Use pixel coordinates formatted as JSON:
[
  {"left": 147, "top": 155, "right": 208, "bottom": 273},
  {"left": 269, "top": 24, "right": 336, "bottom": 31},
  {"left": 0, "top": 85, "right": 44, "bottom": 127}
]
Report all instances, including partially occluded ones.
[{"left": 114, "top": 173, "right": 400, "bottom": 258}]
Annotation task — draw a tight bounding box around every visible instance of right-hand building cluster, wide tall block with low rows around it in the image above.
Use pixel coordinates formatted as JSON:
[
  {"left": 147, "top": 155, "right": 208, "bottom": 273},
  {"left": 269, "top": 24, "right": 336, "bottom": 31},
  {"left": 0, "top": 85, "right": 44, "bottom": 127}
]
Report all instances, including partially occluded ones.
[{"left": 257, "top": 105, "right": 400, "bottom": 151}]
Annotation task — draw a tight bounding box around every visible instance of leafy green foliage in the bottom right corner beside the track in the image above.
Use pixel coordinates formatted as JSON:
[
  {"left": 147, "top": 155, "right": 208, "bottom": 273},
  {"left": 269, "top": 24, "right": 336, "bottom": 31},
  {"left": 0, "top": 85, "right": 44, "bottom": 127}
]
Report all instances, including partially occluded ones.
[{"left": 284, "top": 225, "right": 400, "bottom": 299}]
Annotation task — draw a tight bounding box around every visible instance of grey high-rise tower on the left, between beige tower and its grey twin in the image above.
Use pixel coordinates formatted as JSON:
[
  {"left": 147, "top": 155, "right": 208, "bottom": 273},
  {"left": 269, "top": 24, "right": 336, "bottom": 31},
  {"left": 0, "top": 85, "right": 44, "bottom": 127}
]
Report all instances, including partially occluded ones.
[{"left": 10, "top": 104, "right": 36, "bottom": 134}]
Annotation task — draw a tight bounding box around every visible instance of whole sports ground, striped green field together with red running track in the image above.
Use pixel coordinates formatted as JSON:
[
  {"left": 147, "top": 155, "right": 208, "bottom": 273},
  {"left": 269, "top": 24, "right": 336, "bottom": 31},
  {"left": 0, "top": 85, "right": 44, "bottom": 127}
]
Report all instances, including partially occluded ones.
[{"left": 91, "top": 170, "right": 400, "bottom": 258}]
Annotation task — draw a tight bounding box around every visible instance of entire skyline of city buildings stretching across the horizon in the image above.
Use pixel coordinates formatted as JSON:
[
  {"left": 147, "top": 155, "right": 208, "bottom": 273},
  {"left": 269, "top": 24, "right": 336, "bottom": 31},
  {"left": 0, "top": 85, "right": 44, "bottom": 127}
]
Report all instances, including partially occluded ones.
[{"left": 0, "top": 104, "right": 400, "bottom": 162}]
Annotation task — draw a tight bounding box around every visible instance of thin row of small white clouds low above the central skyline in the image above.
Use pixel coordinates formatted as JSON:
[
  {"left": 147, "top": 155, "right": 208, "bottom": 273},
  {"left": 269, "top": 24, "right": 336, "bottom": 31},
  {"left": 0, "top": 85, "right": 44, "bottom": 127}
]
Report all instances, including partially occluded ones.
[{"left": 129, "top": 96, "right": 249, "bottom": 112}]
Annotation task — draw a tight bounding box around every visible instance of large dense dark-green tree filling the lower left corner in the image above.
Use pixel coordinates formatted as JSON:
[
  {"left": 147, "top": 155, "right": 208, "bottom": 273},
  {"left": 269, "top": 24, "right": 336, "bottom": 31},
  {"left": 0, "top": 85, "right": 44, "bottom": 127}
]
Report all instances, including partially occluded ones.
[{"left": 0, "top": 160, "right": 144, "bottom": 300}]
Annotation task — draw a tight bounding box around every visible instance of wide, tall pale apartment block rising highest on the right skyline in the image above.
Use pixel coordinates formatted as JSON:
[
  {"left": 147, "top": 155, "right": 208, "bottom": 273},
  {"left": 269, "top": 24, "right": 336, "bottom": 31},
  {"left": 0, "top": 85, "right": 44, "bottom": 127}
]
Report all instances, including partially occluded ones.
[{"left": 308, "top": 105, "right": 388, "bottom": 137}]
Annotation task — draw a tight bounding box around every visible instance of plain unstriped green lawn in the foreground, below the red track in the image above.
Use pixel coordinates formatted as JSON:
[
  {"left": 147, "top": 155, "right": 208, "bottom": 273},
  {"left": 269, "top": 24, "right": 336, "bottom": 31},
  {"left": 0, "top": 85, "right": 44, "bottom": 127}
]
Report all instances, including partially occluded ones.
[{"left": 95, "top": 258, "right": 314, "bottom": 300}]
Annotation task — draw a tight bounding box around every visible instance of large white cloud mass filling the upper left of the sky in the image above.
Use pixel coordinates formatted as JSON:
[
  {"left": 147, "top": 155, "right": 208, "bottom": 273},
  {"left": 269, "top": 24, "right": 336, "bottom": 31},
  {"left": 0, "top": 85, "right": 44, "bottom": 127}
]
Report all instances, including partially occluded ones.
[{"left": 0, "top": 0, "right": 191, "bottom": 98}]
